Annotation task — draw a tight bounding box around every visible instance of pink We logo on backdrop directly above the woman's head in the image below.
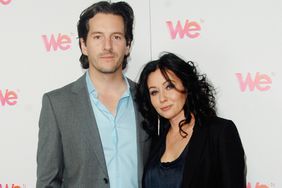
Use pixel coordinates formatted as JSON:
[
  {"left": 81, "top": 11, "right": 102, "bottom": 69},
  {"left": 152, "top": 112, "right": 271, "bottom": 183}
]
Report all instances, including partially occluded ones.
[{"left": 166, "top": 20, "right": 201, "bottom": 39}]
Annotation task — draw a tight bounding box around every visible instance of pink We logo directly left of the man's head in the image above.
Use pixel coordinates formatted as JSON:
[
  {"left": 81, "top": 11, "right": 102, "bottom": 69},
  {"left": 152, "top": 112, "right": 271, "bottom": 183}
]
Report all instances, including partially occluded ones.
[{"left": 42, "top": 33, "right": 71, "bottom": 52}]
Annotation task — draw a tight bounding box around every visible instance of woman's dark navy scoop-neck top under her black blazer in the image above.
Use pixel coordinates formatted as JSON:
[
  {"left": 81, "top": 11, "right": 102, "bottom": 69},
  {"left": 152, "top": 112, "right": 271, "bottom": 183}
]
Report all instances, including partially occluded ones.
[{"left": 143, "top": 141, "right": 189, "bottom": 188}]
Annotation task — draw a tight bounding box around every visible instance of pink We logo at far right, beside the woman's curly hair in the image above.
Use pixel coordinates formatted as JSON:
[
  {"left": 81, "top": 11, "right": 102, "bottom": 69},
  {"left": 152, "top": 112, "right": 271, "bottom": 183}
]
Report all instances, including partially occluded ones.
[{"left": 236, "top": 72, "right": 272, "bottom": 92}]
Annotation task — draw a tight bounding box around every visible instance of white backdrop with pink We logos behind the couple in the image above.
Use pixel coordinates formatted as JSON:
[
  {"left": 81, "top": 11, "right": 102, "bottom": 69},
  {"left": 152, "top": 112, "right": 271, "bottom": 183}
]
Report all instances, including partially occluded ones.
[{"left": 0, "top": 0, "right": 282, "bottom": 188}]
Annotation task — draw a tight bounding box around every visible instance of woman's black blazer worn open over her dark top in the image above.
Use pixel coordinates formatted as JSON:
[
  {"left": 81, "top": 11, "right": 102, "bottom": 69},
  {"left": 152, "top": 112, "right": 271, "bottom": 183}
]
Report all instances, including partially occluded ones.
[{"left": 145, "top": 117, "right": 246, "bottom": 188}]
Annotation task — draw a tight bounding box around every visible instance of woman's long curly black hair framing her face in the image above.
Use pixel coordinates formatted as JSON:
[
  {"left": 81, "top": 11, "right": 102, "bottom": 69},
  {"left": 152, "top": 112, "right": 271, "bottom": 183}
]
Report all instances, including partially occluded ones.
[{"left": 136, "top": 53, "right": 216, "bottom": 137}]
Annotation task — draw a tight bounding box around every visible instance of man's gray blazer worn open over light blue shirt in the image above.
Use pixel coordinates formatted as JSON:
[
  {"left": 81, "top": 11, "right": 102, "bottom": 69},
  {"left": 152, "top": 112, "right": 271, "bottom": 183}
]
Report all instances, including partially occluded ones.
[{"left": 36, "top": 74, "right": 149, "bottom": 188}]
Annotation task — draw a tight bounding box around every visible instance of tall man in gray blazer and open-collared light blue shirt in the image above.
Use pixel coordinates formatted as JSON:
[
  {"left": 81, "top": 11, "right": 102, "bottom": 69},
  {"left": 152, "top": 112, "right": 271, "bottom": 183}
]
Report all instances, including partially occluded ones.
[{"left": 36, "top": 1, "right": 149, "bottom": 188}]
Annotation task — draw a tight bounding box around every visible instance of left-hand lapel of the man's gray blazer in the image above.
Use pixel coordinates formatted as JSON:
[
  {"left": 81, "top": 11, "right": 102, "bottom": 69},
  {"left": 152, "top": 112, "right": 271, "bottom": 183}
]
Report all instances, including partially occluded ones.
[{"left": 72, "top": 74, "right": 108, "bottom": 175}]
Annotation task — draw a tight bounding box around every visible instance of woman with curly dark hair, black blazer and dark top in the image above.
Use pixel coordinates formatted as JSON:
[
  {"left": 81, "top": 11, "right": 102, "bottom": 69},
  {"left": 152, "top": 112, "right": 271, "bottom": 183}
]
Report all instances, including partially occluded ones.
[{"left": 136, "top": 53, "right": 246, "bottom": 188}]
